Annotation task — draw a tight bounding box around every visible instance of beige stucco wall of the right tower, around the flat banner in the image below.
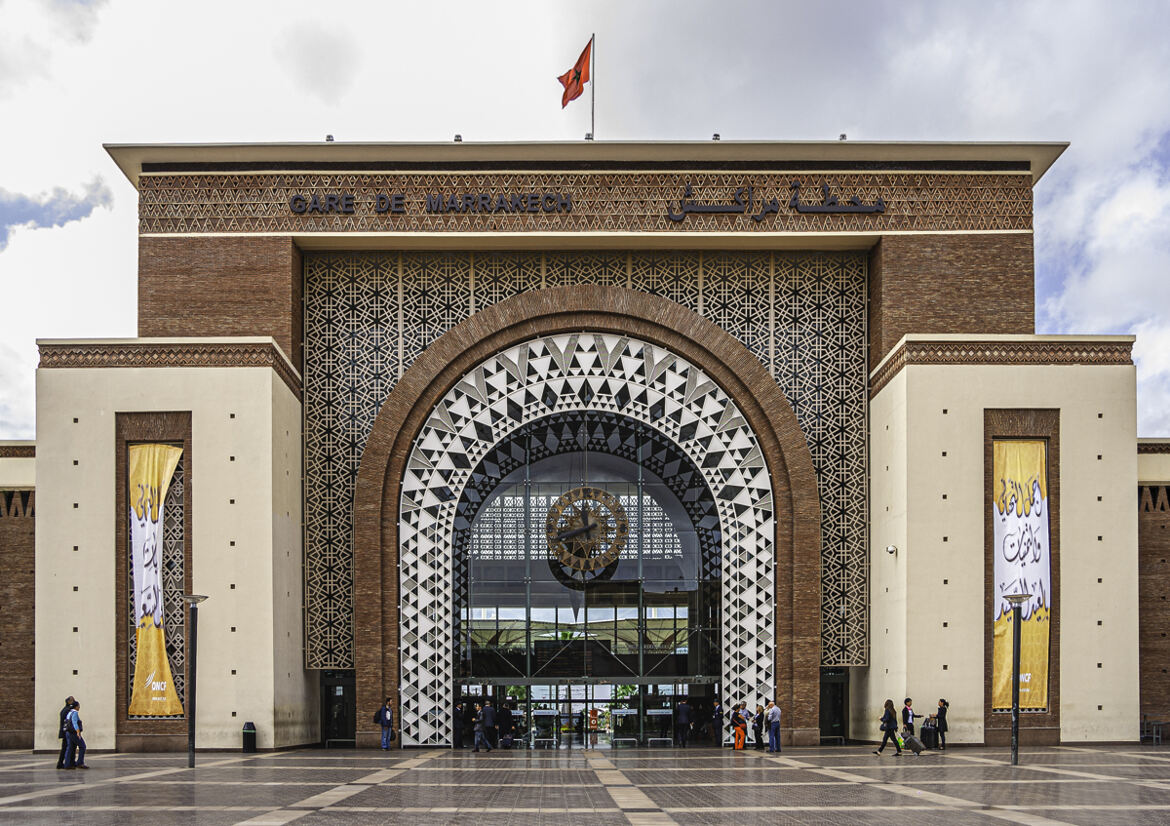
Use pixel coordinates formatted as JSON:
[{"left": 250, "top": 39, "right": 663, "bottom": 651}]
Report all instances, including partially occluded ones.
[{"left": 853, "top": 343, "right": 1138, "bottom": 742}]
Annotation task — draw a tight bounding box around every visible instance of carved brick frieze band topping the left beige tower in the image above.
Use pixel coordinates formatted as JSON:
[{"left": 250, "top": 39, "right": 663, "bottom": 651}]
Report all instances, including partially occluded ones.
[{"left": 40, "top": 342, "right": 301, "bottom": 399}]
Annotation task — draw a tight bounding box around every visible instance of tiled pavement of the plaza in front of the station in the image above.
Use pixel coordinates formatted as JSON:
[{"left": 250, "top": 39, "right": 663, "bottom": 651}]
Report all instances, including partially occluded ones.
[{"left": 0, "top": 746, "right": 1170, "bottom": 826}]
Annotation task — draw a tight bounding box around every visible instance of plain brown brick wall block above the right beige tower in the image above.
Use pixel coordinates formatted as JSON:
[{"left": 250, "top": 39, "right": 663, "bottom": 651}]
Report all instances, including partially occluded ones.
[{"left": 869, "top": 233, "right": 1035, "bottom": 370}]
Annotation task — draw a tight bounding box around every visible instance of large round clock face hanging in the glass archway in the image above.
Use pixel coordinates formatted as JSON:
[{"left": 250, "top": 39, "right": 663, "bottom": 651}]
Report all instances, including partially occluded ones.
[{"left": 545, "top": 487, "right": 629, "bottom": 584}]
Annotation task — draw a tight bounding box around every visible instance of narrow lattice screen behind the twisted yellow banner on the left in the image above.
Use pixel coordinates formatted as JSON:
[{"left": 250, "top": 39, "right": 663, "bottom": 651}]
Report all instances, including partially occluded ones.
[{"left": 124, "top": 456, "right": 187, "bottom": 720}]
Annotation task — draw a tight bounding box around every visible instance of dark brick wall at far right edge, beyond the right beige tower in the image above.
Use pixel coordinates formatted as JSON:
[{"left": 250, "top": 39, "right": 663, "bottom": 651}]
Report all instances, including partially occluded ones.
[{"left": 1137, "top": 484, "right": 1170, "bottom": 720}]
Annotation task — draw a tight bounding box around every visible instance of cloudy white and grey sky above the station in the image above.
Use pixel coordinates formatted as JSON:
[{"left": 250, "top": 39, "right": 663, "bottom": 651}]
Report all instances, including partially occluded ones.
[{"left": 0, "top": 0, "right": 1170, "bottom": 439}]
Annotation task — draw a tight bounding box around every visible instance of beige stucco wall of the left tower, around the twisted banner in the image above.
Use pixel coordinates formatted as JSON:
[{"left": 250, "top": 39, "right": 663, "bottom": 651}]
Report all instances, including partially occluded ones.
[{"left": 35, "top": 343, "right": 317, "bottom": 749}]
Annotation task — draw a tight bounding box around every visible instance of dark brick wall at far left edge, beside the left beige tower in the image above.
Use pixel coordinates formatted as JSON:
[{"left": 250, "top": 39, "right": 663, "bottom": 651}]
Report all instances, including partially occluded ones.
[{"left": 0, "top": 490, "right": 36, "bottom": 749}]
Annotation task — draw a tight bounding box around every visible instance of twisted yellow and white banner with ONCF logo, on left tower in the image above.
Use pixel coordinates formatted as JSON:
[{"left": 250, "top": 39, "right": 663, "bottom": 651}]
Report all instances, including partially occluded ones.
[{"left": 128, "top": 445, "right": 183, "bottom": 717}]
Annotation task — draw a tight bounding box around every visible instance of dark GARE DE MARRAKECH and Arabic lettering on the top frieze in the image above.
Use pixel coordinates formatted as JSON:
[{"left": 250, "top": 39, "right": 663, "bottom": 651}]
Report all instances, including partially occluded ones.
[{"left": 289, "top": 181, "right": 886, "bottom": 223}]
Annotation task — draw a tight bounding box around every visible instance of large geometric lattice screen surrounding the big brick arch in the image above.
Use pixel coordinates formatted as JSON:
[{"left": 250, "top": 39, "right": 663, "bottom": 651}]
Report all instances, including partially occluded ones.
[{"left": 304, "top": 252, "right": 869, "bottom": 668}]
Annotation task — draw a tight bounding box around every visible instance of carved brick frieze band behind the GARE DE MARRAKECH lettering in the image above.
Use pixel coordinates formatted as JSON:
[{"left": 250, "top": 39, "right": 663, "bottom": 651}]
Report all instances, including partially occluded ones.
[{"left": 138, "top": 172, "right": 1032, "bottom": 234}]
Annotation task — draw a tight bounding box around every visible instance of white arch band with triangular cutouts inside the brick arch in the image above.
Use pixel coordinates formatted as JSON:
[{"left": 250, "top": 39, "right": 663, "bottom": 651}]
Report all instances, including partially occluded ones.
[{"left": 399, "top": 332, "right": 776, "bottom": 745}]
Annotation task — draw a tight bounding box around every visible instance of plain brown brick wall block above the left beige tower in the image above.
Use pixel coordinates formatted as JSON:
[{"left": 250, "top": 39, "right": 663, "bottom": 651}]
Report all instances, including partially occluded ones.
[{"left": 138, "top": 238, "right": 304, "bottom": 371}]
